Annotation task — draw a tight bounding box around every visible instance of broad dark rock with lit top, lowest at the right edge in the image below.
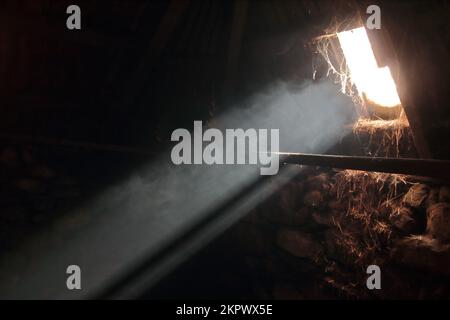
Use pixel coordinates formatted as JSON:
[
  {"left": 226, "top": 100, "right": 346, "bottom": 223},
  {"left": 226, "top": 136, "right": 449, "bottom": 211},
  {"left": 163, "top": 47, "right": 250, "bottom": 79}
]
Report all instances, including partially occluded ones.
[{"left": 391, "top": 236, "right": 450, "bottom": 276}]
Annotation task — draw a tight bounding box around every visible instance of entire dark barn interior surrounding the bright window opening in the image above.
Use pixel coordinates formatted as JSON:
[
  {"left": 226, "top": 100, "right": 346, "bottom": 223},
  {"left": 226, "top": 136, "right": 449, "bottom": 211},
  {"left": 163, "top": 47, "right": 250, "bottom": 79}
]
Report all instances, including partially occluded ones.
[{"left": 0, "top": 0, "right": 450, "bottom": 300}]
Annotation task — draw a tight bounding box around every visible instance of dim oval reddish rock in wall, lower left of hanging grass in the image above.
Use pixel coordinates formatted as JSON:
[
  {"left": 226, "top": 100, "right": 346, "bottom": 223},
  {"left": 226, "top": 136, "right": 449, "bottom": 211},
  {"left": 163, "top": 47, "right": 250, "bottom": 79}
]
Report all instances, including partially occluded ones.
[{"left": 277, "top": 229, "right": 322, "bottom": 258}]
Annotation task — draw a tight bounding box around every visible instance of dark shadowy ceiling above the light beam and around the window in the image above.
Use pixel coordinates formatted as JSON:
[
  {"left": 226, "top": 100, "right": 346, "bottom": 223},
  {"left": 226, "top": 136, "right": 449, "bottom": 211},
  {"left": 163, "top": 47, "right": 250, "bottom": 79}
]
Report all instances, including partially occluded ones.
[{"left": 0, "top": 0, "right": 450, "bottom": 158}]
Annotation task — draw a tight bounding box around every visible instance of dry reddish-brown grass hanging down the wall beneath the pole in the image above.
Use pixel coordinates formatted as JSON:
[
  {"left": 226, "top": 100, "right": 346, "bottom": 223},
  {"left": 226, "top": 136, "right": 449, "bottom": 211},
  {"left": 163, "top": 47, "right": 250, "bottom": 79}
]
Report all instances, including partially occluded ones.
[{"left": 332, "top": 170, "right": 411, "bottom": 265}]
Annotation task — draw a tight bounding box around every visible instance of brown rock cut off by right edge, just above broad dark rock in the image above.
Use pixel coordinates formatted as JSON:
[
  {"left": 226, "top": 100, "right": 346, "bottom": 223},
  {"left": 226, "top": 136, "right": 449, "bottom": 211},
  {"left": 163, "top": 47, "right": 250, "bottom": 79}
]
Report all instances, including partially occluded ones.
[{"left": 427, "top": 202, "right": 450, "bottom": 243}]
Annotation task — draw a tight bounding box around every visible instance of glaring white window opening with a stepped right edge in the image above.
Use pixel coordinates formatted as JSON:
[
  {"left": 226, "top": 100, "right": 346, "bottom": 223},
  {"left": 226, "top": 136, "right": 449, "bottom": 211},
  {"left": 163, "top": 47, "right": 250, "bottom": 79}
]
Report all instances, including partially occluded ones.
[{"left": 337, "top": 27, "right": 400, "bottom": 107}]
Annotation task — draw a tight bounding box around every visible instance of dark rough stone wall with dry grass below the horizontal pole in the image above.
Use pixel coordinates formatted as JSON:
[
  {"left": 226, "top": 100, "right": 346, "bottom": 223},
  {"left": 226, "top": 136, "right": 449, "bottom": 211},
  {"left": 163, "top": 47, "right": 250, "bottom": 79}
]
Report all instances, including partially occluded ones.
[{"left": 221, "top": 169, "right": 450, "bottom": 299}]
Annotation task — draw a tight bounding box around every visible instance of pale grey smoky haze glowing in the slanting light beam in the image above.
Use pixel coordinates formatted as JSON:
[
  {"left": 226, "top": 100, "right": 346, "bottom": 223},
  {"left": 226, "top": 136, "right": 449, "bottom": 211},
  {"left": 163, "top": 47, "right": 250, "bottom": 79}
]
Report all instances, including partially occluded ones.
[{"left": 0, "top": 82, "right": 353, "bottom": 298}]
